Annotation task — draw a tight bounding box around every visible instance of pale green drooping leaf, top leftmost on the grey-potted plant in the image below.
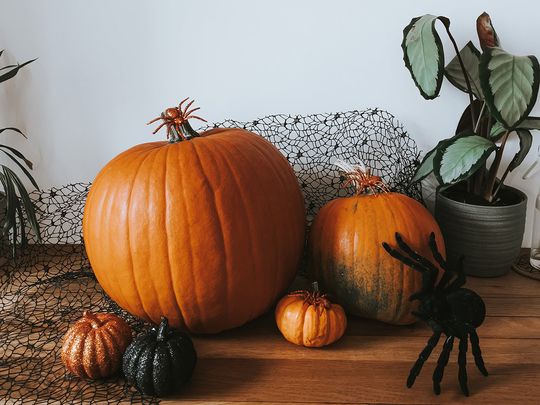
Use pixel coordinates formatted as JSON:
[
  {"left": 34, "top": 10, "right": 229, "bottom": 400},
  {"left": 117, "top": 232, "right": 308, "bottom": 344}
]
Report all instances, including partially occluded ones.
[{"left": 401, "top": 14, "right": 450, "bottom": 100}]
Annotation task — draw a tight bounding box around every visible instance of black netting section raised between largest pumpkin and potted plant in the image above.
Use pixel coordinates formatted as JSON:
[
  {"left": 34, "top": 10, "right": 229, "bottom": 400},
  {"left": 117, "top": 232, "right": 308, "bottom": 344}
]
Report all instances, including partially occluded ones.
[{"left": 214, "top": 108, "right": 421, "bottom": 222}]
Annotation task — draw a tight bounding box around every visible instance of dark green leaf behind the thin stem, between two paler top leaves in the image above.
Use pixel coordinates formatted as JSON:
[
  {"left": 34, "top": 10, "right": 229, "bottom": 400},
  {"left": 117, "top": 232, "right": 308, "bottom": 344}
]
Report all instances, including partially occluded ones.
[{"left": 444, "top": 41, "right": 484, "bottom": 100}]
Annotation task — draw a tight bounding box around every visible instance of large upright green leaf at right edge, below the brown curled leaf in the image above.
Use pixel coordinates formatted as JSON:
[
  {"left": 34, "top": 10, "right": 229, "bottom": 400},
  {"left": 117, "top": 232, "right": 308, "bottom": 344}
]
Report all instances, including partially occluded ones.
[{"left": 480, "top": 48, "right": 540, "bottom": 129}]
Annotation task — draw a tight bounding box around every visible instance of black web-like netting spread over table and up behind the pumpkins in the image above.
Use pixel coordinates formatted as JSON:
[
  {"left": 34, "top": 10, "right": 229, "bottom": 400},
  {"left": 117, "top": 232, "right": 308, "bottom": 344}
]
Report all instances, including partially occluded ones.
[{"left": 0, "top": 109, "right": 420, "bottom": 403}]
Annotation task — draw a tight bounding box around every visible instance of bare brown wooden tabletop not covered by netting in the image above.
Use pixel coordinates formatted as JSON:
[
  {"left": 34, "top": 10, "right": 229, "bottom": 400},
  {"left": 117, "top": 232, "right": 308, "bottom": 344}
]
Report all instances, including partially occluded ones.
[{"left": 164, "top": 272, "right": 540, "bottom": 404}]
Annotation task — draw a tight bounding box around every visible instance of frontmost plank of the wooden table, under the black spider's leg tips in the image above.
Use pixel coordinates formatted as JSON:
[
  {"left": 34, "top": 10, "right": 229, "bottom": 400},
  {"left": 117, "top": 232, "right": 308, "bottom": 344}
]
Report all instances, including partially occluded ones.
[{"left": 167, "top": 358, "right": 540, "bottom": 404}]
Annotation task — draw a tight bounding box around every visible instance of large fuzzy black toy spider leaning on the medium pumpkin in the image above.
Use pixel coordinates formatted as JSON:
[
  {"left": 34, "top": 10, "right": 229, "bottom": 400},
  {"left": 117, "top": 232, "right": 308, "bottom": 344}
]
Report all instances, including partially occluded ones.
[{"left": 383, "top": 233, "right": 488, "bottom": 396}]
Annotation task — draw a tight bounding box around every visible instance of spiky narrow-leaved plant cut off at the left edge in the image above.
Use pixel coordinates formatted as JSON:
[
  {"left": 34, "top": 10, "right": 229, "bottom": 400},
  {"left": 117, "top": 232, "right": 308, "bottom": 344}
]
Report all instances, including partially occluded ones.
[{"left": 0, "top": 51, "right": 41, "bottom": 255}]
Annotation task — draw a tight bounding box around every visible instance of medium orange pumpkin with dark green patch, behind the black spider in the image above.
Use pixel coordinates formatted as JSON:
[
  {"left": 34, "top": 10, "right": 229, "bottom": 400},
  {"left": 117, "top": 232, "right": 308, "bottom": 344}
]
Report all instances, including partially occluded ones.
[{"left": 308, "top": 162, "right": 444, "bottom": 325}]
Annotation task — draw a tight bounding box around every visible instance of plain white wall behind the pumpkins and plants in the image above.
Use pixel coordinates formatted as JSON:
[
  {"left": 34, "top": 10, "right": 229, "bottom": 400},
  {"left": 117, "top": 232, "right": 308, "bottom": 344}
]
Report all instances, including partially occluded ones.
[{"left": 0, "top": 0, "right": 540, "bottom": 244}]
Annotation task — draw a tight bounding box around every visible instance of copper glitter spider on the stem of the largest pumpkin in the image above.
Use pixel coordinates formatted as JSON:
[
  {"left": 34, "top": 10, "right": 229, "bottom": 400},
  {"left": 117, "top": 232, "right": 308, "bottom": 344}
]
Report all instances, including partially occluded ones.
[{"left": 146, "top": 97, "right": 207, "bottom": 142}]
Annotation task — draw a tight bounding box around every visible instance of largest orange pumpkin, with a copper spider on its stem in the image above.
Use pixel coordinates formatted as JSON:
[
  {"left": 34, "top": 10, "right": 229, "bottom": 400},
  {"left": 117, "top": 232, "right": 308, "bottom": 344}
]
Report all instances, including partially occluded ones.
[{"left": 83, "top": 99, "right": 305, "bottom": 333}]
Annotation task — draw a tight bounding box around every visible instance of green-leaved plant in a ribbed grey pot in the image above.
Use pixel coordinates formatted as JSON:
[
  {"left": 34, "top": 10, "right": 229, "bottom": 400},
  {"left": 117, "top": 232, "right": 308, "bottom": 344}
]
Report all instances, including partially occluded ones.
[{"left": 402, "top": 13, "right": 540, "bottom": 277}]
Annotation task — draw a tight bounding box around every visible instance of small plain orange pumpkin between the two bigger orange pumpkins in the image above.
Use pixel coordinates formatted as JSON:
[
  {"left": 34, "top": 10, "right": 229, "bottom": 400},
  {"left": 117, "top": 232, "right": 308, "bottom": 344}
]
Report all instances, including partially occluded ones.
[{"left": 276, "top": 283, "right": 347, "bottom": 347}]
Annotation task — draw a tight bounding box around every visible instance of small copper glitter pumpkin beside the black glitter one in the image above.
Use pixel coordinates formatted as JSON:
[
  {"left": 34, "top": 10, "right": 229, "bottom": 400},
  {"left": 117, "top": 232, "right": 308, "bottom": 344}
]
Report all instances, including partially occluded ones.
[{"left": 61, "top": 311, "right": 131, "bottom": 379}]
